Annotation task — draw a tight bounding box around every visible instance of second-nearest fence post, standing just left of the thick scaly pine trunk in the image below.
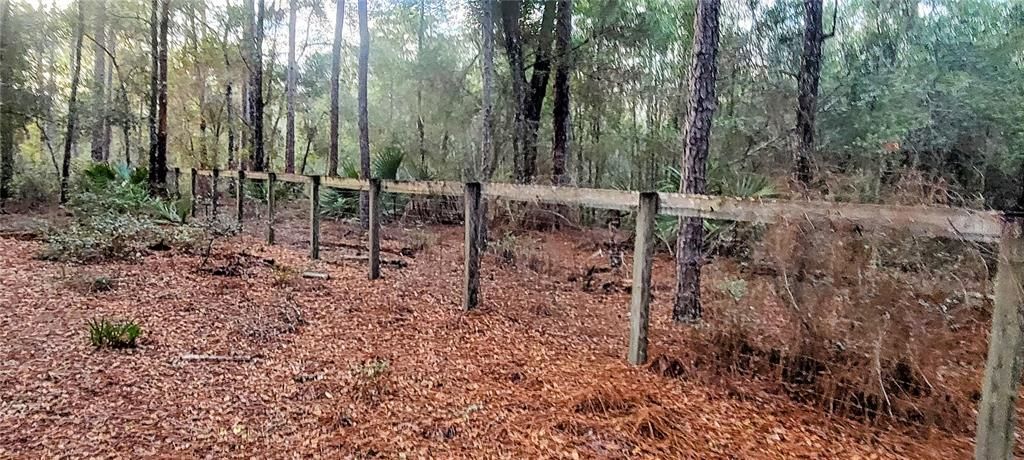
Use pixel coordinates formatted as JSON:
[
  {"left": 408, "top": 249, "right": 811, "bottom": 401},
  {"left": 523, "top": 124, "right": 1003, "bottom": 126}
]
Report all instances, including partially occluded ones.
[{"left": 629, "top": 192, "right": 658, "bottom": 365}]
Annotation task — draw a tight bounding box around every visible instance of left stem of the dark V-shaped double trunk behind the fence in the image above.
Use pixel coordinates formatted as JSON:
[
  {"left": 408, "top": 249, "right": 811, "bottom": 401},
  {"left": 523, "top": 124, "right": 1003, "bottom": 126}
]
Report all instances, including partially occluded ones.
[{"left": 499, "top": 0, "right": 530, "bottom": 182}]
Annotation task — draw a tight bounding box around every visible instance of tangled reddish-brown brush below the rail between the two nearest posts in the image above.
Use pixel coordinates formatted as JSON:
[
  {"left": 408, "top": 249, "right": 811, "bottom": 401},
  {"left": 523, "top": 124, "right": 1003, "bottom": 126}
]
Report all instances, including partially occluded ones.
[{"left": 693, "top": 222, "right": 991, "bottom": 432}]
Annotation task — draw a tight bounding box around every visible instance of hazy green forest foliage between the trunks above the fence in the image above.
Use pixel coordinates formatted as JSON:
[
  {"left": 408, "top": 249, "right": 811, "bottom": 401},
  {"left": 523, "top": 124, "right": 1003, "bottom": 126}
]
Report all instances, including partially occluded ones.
[{"left": 0, "top": 0, "right": 1024, "bottom": 208}]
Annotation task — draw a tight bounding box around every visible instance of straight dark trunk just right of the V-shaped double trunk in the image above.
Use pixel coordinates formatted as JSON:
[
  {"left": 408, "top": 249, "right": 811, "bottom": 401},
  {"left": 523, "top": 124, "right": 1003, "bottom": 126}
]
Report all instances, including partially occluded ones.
[{"left": 551, "top": 0, "right": 572, "bottom": 185}]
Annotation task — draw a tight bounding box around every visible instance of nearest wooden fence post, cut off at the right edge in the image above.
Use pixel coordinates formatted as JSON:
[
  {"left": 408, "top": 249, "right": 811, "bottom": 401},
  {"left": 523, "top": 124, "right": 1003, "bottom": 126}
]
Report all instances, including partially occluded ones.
[{"left": 974, "top": 216, "right": 1024, "bottom": 460}]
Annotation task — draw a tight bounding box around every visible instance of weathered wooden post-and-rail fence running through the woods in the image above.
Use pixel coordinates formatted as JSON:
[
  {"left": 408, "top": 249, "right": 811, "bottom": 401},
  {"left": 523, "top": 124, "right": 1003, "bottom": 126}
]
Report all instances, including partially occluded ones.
[{"left": 180, "top": 168, "right": 1024, "bottom": 459}]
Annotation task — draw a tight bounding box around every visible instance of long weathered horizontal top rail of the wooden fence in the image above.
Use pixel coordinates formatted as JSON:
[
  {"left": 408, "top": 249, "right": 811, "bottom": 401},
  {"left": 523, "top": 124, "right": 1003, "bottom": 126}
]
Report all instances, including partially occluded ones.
[{"left": 196, "top": 170, "right": 1004, "bottom": 242}]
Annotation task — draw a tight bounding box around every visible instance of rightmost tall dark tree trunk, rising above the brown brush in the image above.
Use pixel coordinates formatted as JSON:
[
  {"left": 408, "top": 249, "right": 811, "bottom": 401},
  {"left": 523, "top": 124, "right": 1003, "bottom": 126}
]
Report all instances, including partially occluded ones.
[{"left": 794, "top": 0, "right": 825, "bottom": 190}]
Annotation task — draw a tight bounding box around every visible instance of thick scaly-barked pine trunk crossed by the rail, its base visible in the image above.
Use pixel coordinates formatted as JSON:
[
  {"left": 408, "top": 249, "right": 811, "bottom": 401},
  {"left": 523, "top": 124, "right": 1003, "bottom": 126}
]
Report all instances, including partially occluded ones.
[{"left": 672, "top": 0, "right": 720, "bottom": 323}]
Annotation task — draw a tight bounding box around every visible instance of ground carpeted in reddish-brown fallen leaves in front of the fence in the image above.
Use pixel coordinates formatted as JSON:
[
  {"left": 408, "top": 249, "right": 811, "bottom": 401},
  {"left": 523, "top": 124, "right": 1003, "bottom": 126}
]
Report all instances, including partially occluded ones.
[{"left": 0, "top": 205, "right": 972, "bottom": 459}]
